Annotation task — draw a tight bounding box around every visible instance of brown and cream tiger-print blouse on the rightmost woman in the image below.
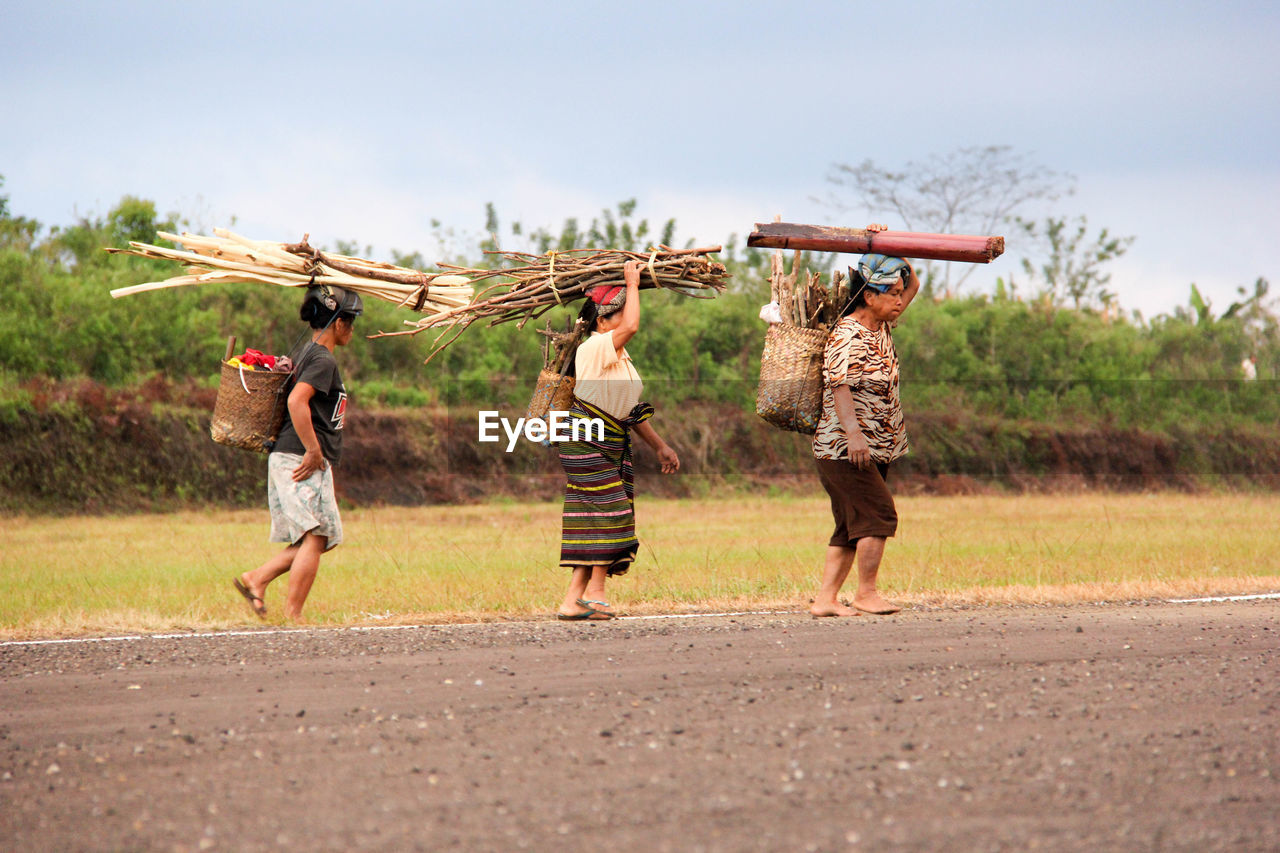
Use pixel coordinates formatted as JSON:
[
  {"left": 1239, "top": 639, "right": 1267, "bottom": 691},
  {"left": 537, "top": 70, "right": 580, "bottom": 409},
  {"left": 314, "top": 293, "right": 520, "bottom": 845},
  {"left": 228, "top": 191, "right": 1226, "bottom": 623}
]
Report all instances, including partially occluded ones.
[{"left": 813, "top": 316, "right": 908, "bottom": 462}]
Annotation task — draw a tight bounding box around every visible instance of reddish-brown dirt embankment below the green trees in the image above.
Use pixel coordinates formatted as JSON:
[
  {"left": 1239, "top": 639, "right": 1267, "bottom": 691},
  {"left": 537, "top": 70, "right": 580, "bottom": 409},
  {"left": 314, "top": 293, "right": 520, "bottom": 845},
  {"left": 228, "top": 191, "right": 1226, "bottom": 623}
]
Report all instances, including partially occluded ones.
[{"left": 0, "top": 379, "right": 1280, "bottom": 512}]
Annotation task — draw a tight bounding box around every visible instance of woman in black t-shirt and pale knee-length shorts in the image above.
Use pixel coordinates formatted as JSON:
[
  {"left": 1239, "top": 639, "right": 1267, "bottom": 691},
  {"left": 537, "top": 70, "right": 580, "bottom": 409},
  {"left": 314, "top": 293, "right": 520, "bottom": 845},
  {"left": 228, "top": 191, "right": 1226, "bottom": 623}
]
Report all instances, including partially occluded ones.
[{"left": 233, "top": 284, "right": 364, "bottom": 621}]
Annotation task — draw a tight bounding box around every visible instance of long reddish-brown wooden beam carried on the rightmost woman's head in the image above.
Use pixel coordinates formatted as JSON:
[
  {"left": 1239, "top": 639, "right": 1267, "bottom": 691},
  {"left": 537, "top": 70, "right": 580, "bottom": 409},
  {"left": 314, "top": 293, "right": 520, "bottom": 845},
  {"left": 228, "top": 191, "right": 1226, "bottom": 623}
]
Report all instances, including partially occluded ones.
[{"left": 746, "top": 222, "right": 1005, "bottom": 264}]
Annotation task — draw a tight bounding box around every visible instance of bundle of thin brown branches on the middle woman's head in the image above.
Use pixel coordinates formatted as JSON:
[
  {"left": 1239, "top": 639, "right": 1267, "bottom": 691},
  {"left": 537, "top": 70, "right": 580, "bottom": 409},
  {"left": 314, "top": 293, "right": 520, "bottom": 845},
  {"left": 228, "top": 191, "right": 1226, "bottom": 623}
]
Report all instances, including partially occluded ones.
[{"left": 372, "top": 246, "right": 728, "bottom": 361}]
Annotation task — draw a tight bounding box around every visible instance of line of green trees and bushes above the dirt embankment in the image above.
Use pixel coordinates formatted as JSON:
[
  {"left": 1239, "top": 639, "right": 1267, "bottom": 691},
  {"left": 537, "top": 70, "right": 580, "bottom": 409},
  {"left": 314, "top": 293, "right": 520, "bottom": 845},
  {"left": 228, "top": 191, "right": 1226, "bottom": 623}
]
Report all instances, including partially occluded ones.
[{"left": 0, "top": 170, "right": 1280, "bottom": 429}]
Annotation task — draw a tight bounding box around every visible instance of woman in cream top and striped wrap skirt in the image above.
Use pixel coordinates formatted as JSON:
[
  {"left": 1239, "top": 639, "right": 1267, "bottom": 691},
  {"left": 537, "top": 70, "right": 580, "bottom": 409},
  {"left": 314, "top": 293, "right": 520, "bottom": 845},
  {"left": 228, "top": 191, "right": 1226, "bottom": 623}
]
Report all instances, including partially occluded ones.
[{"left": 558, "top": 260, "right": 680, "bottom": 621}]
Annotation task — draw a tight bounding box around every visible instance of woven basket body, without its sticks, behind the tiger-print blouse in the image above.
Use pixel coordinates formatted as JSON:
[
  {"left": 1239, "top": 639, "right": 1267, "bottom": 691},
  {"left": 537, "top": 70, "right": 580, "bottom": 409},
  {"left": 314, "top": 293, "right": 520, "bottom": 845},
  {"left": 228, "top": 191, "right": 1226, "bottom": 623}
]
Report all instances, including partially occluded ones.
[{"left": 755, "top": 323, "right": 827, "bottom": 435}]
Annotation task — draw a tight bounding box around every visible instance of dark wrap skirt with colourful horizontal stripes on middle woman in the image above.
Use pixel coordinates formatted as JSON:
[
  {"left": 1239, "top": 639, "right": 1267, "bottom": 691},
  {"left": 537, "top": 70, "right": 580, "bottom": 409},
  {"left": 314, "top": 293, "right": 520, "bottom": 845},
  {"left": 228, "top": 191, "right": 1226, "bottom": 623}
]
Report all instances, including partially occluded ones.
[{"left": 559, "top": 397, "right": 653, "bottom": 575}]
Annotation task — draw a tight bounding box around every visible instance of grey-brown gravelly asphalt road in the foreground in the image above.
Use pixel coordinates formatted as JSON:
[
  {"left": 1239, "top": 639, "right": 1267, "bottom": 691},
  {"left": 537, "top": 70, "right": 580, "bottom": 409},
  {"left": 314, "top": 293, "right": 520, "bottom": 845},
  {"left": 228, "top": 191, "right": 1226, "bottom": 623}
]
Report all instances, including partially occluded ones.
[{"left": 0, "top": 601, "right": 1280, "bottom": 852}]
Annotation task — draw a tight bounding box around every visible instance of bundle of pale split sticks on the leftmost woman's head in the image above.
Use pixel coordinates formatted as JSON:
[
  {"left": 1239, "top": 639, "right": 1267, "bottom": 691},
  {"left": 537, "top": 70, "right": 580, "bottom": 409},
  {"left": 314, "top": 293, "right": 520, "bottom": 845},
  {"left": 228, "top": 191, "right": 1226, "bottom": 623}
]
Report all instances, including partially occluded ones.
[{"left": 106, "top": 228, "right": 475, "bottom": 321}]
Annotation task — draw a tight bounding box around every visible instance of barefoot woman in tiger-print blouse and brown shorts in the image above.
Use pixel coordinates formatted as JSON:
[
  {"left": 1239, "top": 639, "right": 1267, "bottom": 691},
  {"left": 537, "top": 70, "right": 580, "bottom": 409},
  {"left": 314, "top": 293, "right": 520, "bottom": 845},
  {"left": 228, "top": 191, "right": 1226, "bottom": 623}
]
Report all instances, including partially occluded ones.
[{"left": 809, "top": 249, "right": 920, "bottom": 616}]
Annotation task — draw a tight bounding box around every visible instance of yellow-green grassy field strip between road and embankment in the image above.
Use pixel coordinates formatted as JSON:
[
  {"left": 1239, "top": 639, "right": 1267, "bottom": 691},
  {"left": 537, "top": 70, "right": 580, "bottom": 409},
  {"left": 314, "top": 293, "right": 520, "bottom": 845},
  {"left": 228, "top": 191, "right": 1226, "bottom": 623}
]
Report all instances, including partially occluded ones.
[{"left": 0, "top": 494, "right": 1280, "bottom": 639}]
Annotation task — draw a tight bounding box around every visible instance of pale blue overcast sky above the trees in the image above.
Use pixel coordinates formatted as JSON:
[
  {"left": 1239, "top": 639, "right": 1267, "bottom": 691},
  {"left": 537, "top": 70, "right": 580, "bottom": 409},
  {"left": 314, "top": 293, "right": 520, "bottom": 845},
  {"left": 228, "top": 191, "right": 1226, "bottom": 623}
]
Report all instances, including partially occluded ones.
[{"left": 0, "top": 0, "right": 1280, "bottom": 316}]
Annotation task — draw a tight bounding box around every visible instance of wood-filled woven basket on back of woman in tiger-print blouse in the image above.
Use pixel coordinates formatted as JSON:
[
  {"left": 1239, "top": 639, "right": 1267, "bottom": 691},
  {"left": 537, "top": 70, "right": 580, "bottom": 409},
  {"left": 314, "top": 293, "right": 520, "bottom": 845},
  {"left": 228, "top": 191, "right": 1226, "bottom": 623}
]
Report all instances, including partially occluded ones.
[{"left": 755, "top": 245, "right": 847, "bottom": 435}]
